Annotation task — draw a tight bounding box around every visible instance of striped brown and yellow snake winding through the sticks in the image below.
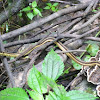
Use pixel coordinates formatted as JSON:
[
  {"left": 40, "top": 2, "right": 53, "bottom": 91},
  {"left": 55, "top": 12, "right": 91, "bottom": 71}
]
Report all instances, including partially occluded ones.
[{"left": 0, "top": 37, "right": 100, "bottom": 66}]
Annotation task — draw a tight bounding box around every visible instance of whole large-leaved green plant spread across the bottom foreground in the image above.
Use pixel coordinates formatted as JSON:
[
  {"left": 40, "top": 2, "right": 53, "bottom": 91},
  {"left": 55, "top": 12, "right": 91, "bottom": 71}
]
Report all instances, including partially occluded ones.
[{"left": 0, "top": 50, "right": 97, "bottom": 100}]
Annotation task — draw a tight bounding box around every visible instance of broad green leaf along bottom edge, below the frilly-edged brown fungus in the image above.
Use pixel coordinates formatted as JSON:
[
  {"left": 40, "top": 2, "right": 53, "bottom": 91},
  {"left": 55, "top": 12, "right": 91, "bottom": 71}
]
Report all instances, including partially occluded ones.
[{"left": 66, "top": 90, "right": 97, "bottom": 100}]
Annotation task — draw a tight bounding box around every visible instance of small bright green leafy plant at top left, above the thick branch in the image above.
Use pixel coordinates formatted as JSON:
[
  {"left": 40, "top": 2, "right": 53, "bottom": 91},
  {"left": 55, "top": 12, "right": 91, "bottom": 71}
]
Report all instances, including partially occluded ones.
[{"left": 19, "top": 1, "right": 42, "bottom": 20}]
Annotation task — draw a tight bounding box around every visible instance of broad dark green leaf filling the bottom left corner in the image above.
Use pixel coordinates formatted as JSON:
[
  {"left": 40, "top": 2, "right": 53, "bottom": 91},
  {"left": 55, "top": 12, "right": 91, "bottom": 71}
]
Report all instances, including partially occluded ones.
[{"left": 0, "top": 88, "right": 29, "bottom": 100}]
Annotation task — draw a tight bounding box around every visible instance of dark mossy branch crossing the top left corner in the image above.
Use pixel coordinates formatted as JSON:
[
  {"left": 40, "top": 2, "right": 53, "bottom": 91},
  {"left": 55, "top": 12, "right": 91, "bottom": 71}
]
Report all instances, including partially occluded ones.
[{"left": 0, "top": 0, "right": 37, "bottom": 25}]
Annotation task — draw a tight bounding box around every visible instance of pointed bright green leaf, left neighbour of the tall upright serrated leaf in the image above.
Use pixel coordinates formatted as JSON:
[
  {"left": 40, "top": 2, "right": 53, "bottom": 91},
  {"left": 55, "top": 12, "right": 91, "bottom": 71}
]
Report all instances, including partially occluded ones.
[{"left": 28, "top": 66, "right": 47, "bottom": 94}]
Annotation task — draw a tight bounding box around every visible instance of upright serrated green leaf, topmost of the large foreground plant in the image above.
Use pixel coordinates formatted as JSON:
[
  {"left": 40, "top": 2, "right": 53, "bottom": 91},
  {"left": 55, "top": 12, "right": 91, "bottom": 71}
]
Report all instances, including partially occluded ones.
[{"left": 42, "top": 49, "right": 64, "bottom": 80}]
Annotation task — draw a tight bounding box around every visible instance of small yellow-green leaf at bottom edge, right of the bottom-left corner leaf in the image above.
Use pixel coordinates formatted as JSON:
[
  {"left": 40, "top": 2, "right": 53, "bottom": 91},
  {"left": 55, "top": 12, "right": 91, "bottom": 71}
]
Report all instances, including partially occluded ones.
[{"left": 27, "top": 90, "right": 44, "bottom": 100}]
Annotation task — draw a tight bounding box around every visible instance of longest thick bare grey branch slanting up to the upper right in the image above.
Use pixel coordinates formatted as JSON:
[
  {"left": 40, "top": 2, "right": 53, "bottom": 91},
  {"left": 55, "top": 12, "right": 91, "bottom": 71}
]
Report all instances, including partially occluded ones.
[{"left": 2, "top": 3, "right": 89, "bottom": 40}]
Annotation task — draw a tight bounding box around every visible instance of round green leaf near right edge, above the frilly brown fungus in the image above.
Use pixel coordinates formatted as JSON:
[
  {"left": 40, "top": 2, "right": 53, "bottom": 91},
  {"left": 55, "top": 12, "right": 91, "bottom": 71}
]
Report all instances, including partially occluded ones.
[{"left": 87, "top": 44, "right": 99, "bottom": 56}]
